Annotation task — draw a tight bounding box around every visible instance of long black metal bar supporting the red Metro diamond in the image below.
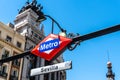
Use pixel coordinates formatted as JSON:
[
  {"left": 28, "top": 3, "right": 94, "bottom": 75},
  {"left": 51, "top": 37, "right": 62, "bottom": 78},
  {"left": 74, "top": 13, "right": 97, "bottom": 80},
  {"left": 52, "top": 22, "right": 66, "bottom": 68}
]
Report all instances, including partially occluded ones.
[{"left": 0, "top": 25, "right": 120, "bottom": 64}]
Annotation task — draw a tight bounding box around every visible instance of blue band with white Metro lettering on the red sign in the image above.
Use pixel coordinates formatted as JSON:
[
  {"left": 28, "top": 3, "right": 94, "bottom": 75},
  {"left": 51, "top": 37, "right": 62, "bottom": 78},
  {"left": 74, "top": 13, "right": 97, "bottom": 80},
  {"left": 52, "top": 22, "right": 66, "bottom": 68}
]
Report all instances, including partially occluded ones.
[{"left": 39, "top": 39, "right": 60, "bottom": 52}]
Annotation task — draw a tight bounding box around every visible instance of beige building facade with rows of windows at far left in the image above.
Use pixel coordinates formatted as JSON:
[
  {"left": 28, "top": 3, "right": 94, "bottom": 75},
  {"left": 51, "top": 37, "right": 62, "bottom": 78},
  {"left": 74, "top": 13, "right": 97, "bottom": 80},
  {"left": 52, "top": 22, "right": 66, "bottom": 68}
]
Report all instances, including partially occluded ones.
[{"left": 0, "top": 22, "right": 25, "bottom": 80}]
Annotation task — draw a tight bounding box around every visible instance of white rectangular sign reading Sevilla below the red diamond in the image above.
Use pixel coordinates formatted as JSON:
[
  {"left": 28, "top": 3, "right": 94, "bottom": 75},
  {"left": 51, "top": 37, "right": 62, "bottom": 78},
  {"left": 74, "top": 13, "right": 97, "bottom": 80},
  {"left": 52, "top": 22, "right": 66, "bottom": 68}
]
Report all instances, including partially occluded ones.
[{"left": 30, "top": 61, "right": 72, "bottom": 76}]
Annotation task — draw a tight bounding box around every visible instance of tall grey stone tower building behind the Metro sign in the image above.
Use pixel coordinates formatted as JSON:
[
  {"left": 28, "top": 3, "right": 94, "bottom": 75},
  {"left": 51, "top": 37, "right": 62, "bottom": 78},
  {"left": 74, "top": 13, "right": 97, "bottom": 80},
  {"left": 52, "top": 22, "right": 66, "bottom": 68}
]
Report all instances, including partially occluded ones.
[{"left": 15, "top": 3, "right": 45, "bottom": 80}]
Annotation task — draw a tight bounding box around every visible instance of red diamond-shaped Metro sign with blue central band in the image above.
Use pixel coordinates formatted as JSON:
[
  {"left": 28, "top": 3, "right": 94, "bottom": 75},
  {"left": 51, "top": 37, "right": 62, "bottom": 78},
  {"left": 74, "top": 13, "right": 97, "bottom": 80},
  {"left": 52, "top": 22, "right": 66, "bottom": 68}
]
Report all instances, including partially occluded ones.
[{"left": 31, "top": 34, "right": 72, "bottom": 61}]
